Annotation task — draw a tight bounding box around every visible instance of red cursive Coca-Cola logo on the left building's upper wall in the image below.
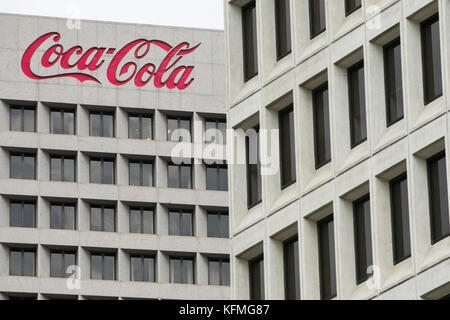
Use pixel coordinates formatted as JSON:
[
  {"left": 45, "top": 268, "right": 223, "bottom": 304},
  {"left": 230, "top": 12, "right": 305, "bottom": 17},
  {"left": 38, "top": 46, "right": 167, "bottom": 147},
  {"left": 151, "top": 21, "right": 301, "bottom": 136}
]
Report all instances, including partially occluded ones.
[{"left": 21, "top": 32, "right": 200, "bottom": 90}]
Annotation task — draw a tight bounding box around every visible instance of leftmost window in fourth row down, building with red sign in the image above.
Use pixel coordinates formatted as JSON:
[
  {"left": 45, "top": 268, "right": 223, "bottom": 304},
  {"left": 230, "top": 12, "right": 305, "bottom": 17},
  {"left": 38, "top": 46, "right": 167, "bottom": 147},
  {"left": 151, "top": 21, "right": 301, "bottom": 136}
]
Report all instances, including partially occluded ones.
[{"left": 9, "top": 249, "right": 36, "bottom": 277}]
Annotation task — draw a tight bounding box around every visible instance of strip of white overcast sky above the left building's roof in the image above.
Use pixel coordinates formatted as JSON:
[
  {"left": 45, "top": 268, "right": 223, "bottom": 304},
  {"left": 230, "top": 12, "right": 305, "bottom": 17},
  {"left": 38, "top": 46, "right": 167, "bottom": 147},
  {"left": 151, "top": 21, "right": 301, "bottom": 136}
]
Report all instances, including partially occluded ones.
[{"left": 0, "top": 0, "right": 223, "bottom": 29}]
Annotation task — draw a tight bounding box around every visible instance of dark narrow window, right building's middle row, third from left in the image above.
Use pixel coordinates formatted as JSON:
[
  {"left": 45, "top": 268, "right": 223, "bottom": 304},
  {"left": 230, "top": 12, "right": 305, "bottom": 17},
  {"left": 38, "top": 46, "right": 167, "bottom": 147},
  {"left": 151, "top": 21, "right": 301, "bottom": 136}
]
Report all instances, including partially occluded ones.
[{"left": 313, "top": 83, "right": 331, "bottom": 169}]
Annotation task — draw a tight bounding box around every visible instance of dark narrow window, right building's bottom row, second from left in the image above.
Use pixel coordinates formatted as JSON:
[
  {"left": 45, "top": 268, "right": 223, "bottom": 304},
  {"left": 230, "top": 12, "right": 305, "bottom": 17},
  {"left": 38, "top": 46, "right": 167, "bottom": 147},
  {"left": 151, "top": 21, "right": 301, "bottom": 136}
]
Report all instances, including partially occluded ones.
[{"left": 283, "top": 237, "right": 300, "bottom": 300}]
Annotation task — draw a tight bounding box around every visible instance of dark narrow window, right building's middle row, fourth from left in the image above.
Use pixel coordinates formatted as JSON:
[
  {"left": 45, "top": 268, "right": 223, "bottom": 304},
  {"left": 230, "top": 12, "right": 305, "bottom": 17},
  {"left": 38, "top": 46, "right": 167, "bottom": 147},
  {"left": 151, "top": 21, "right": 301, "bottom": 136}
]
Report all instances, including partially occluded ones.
[{"left": 348, "top": 62, "right": 367, "bottom": 148}]
